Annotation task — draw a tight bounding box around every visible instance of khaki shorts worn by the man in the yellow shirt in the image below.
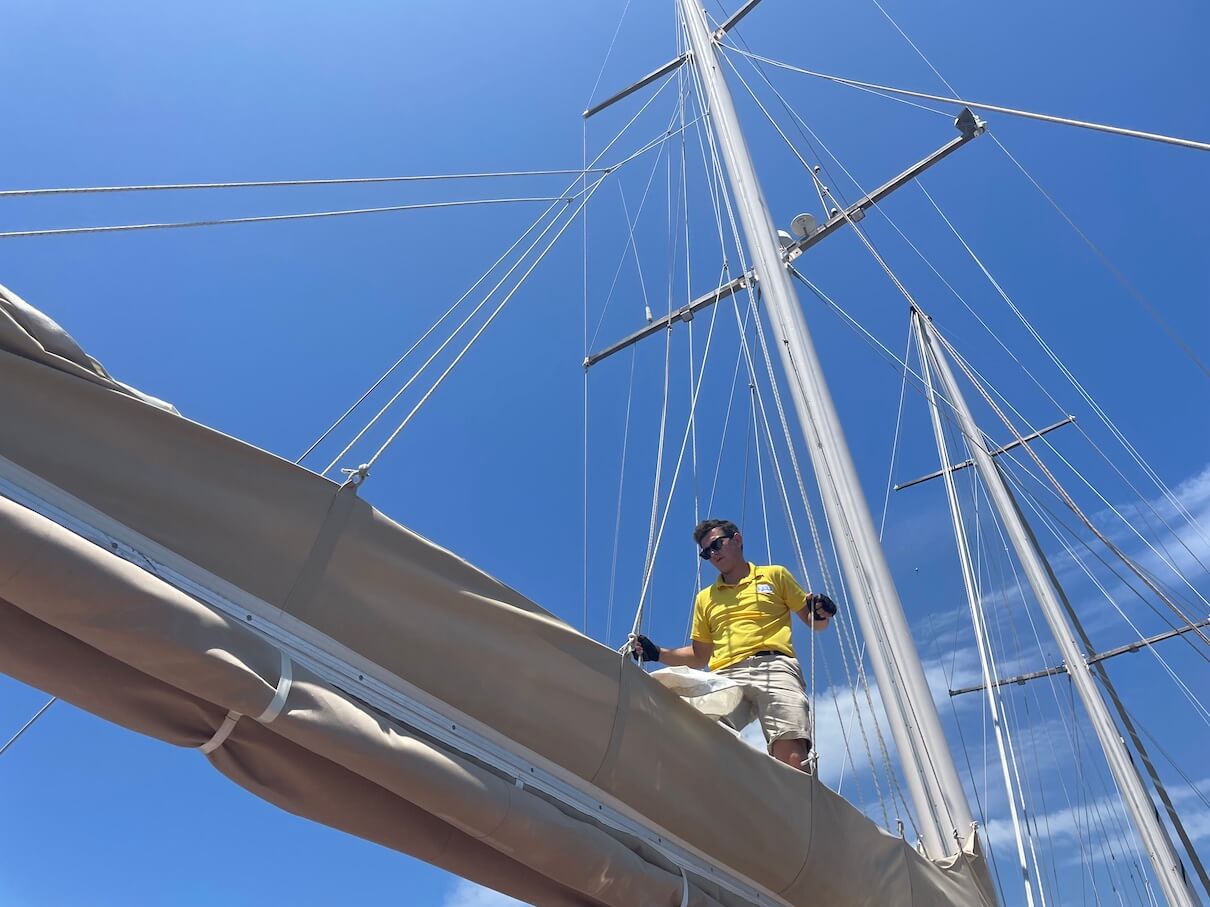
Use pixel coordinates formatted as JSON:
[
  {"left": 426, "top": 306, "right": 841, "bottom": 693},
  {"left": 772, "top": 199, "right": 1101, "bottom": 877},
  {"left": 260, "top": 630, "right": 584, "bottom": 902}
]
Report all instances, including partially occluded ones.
[{"left": 718, "top": 654, "right": 811, "bottom": 747}]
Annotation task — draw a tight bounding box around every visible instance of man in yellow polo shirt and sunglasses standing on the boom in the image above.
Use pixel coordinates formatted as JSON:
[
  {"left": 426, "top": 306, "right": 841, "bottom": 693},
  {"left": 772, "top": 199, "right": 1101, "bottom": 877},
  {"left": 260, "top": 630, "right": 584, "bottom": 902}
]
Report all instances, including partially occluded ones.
[{"left": 634, "top": 520, "right": 836, "bottom": 770}]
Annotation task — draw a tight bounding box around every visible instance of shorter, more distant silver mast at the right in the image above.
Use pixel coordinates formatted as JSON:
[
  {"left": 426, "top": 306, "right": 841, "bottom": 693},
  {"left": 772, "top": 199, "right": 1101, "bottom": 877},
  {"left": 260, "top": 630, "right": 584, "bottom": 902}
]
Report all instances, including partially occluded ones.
[{"left": 912, "top": 308, "right": 1198, "bottom": 907}]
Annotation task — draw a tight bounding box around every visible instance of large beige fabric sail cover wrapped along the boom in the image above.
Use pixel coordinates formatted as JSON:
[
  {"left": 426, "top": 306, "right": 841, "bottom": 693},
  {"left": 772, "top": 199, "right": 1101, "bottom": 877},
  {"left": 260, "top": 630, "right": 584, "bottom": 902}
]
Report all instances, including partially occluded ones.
[{"left": 0, "top": 288, "right": 995, "bottom": 907}]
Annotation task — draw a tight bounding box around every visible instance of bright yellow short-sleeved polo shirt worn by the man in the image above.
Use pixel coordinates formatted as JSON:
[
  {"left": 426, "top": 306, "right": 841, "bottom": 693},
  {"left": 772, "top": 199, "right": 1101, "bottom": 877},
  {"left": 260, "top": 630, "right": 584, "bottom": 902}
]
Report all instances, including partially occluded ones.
[{"left": 690, "top": 564, "right": 807, "bottom": 671}]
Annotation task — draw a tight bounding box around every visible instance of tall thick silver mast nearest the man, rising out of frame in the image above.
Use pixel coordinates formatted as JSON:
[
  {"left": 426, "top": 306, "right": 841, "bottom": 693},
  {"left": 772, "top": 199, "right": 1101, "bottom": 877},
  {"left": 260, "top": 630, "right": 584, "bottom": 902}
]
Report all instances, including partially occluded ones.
[{"left": 678, "top": 0, "right": 972, "bottom": 859}]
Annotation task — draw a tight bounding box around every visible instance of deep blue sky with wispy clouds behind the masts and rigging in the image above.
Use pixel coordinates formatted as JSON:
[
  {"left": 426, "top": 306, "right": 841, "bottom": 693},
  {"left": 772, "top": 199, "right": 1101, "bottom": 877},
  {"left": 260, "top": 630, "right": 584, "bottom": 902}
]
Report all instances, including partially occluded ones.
[{"left": 0, "top": 0, "right": 1210, "bottom": 907}]
